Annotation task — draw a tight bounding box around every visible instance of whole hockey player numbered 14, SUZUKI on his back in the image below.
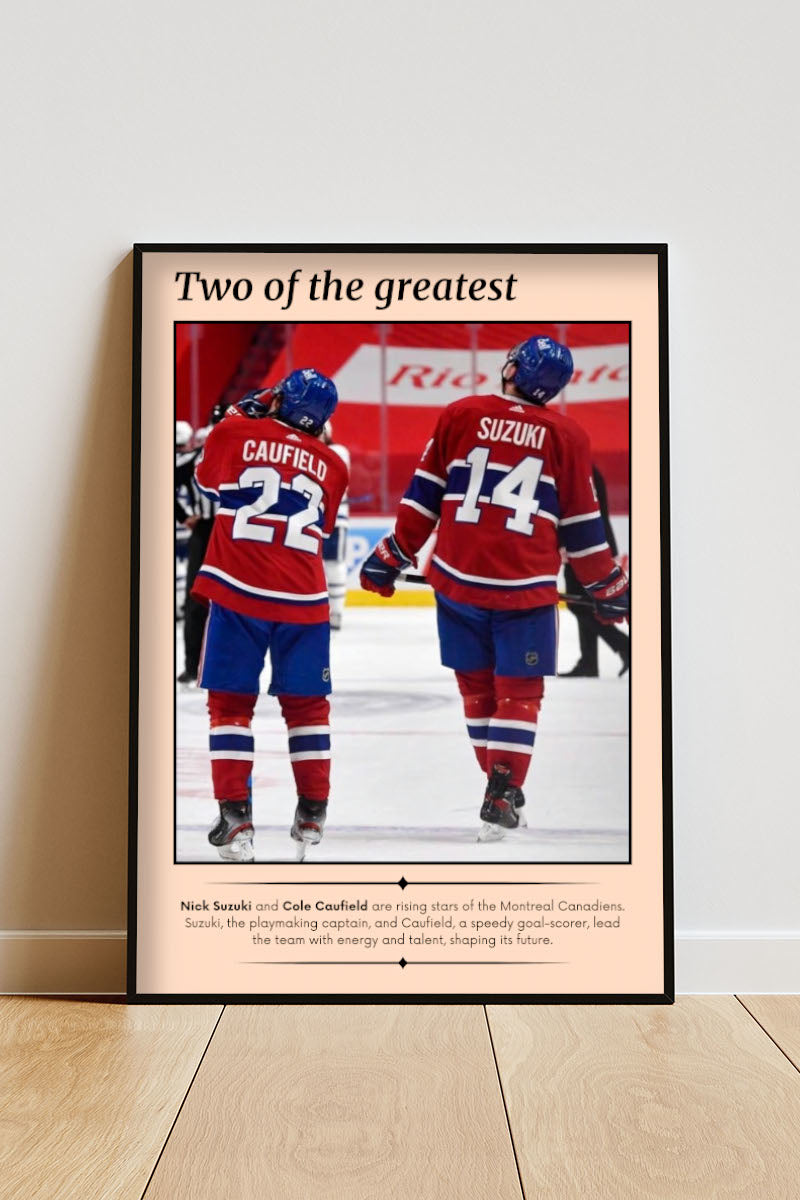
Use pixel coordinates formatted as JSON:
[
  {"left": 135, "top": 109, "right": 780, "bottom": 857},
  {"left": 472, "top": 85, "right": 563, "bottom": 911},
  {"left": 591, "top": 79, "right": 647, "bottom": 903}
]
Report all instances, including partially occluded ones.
[{"left": 361, "top": 337, "right": 628, "bottom": 841}]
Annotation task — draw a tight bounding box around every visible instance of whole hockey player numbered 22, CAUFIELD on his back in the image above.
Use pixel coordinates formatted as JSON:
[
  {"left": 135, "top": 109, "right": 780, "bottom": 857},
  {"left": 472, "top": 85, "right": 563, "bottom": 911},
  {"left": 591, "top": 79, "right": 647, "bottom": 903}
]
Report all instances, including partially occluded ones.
[{"left": 193, "top": 368, "right": 348, "bottom": 862}]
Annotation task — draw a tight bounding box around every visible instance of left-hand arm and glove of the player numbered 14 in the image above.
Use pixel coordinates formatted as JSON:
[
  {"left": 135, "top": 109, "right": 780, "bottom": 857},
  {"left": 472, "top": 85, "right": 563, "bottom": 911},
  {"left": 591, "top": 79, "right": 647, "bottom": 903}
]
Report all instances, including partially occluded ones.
[{"left": 361, "top": 420, "right": 447, "bottom": 596}]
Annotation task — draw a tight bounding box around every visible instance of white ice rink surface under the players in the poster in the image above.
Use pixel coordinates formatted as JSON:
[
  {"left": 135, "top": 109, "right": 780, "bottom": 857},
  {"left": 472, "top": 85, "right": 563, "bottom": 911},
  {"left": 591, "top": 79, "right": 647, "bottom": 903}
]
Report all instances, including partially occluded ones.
[{"left": 176, "top": 606, "right": 628, "bottom": 863}]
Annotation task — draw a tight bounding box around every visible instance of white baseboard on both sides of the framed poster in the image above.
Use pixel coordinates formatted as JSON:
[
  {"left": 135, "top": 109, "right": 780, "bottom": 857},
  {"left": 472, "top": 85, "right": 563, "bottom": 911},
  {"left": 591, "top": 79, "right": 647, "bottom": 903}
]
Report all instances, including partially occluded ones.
[{"left": 0, "top": 929, "right": 800, "bottom": 996}]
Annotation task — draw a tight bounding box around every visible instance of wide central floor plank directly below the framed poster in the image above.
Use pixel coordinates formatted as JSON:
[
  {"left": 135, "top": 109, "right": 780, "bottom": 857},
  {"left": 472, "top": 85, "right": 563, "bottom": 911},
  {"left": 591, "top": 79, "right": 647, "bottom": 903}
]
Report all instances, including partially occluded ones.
[{"left": 146, "top": 1004, "right": 521, "bottom": 1200}]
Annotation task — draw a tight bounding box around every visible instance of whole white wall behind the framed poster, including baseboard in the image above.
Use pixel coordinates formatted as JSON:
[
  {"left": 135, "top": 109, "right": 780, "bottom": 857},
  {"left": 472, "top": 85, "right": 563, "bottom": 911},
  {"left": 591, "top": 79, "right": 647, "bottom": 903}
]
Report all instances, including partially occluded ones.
[{"left": 0, "top": 0, "right": 800, "bottom": 991}]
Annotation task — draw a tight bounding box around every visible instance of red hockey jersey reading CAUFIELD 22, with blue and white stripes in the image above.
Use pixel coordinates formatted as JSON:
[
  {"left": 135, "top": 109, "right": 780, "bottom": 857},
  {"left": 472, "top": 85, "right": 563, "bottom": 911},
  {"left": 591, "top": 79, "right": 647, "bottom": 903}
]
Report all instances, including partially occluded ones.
[{"left": 192, "top": 413, "right": 348, "bottom": 624}]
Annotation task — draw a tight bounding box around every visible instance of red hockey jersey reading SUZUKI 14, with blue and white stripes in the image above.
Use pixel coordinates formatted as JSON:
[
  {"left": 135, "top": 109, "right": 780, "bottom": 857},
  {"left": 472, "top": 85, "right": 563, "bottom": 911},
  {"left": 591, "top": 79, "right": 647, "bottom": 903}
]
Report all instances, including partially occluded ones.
[{"left": 395, "top": 396, "right": 614, "bottom": 608}]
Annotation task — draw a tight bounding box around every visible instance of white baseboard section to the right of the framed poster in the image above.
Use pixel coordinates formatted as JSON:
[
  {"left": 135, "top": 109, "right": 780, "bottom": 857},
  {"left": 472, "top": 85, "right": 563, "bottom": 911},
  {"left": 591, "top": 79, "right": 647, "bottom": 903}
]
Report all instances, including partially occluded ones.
[{"left": 675, "top": 931, "right": 800, "bottom": 996}]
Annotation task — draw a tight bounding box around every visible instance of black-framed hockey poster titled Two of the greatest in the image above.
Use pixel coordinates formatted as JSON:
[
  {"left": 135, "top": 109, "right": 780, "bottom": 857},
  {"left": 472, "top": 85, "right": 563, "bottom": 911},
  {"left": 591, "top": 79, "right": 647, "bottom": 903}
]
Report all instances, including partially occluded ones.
[{"left": 128, "top": 245, "right": 673, "bottom": 1003}]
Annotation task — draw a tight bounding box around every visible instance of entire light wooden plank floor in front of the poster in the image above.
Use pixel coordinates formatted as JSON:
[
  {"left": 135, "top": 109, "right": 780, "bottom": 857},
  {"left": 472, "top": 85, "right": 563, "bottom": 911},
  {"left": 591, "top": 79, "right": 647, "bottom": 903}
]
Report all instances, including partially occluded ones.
[{"left": 0, "top": 996, "right": 800, "bottom": 1200}]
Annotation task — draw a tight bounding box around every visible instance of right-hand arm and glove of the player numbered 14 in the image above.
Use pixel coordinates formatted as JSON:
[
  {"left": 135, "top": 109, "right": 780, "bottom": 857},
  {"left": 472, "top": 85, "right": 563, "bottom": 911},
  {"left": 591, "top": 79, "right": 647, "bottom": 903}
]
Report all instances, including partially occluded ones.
[{"left": 559, "top": 427, "right": 628, "bottom": 623}]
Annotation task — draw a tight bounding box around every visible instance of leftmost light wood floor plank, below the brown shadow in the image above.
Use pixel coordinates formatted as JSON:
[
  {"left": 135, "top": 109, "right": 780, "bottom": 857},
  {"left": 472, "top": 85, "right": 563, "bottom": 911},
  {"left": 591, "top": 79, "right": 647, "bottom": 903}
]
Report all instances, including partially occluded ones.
[{"left": 0, "top": 996, "right": 219, "bottom": 1200}]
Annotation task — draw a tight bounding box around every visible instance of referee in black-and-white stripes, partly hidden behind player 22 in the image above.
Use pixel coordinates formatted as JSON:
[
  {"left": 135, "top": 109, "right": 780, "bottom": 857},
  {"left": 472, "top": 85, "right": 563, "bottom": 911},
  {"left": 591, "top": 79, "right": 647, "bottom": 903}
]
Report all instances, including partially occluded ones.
[{"left": 175, "top": 402, "right": 225, "bottom": 685}]
